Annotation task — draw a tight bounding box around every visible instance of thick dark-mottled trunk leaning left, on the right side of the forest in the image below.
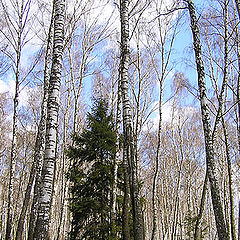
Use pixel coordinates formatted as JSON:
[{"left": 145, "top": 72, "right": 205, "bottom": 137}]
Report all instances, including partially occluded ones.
[{"left": 186, "top": 0, "right": 230, "bottom": 240}]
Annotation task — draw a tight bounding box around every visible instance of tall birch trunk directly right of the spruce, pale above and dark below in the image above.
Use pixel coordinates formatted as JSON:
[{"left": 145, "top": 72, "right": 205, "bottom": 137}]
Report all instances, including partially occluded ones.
[{"left": 120, "top": 0, "right": 145, "bottom": 240}]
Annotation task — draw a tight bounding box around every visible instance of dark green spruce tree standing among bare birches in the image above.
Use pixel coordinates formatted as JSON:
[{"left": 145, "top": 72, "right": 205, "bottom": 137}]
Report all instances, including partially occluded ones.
[{"left": 67, "top": 98, "right": 120, "bottom": 240}]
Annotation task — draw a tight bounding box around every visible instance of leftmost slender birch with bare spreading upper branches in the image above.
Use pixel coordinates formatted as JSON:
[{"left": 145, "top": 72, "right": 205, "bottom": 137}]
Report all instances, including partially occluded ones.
[{"left": 0, "top": 0, "right": 36, "bottom": 239}]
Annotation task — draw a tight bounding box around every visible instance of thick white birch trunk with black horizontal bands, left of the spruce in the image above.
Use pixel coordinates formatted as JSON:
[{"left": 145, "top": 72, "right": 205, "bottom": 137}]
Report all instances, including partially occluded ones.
[{"left": 34, "top": 0, "right": 65, "bottom": 240}]
